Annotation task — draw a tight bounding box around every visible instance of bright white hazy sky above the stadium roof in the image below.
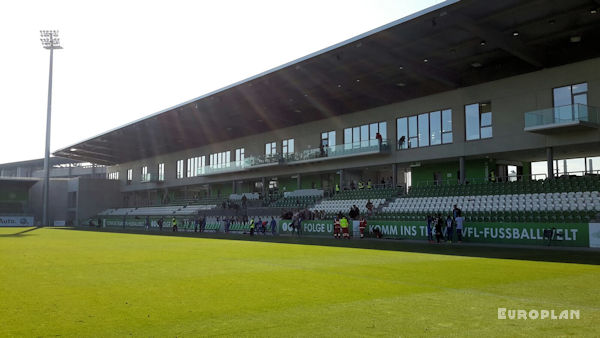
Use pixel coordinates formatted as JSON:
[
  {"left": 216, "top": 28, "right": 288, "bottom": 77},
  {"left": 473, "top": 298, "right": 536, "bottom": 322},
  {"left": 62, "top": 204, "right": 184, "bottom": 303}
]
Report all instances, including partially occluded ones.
[{"left": 0, "top": 0, "right": 442, "bottom": 163}]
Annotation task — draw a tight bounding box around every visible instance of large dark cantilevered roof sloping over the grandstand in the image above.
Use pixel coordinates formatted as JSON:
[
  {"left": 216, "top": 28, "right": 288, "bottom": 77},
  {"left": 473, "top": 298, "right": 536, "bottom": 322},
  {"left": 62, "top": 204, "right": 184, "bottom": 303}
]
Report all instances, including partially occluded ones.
[{"left": 54, "top": 0, "right": 600, "bottom": 165}]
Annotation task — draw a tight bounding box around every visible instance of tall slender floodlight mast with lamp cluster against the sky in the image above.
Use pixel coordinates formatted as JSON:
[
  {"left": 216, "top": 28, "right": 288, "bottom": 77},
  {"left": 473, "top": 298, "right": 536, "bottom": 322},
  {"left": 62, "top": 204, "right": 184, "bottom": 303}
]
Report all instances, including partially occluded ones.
[{"left": 40, "top": 30, "right": 62, "bottom": 226}]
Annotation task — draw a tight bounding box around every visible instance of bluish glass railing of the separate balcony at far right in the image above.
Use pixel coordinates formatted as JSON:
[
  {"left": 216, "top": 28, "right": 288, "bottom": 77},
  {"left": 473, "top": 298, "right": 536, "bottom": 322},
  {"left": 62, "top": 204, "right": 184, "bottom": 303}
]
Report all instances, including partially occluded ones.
[{"left": 525, "top": 104, "right": 599, "bottom": 128}]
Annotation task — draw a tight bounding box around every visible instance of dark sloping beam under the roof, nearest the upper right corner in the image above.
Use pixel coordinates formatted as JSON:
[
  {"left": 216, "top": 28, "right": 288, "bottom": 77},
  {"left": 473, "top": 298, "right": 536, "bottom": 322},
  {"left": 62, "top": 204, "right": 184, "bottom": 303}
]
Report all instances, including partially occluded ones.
[{"left": 454, "top": 13, "right": 544, "bottom": 68}]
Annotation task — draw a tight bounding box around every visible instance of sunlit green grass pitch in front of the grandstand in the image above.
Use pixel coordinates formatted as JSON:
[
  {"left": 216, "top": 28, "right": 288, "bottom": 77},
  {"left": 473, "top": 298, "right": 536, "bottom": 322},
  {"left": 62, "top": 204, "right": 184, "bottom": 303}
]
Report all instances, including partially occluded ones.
[{"left": 0, "top": 228, "right": 600, "bottom": 337}]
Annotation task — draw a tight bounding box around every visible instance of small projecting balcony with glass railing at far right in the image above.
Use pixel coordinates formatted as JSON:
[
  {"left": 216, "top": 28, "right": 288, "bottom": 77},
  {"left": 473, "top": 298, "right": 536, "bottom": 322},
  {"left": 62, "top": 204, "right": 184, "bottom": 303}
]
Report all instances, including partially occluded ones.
[{"left": 524, "top": 104, "right": 600, "bottom": 134}]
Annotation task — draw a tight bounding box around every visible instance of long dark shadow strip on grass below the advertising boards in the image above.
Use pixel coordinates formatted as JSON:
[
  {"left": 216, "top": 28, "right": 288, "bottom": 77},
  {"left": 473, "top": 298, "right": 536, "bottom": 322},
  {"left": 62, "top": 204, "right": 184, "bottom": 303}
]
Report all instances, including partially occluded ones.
[{"left": 60, "top": 227, "right": 600, "bottom": 265}]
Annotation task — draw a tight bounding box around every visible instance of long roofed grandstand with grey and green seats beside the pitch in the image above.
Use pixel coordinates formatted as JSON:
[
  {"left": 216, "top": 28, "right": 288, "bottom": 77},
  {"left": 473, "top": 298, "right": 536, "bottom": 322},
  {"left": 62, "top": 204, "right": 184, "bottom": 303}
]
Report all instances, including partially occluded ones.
[{"left": 36, "top": 0, "right": 600, "bottom": 246}]
